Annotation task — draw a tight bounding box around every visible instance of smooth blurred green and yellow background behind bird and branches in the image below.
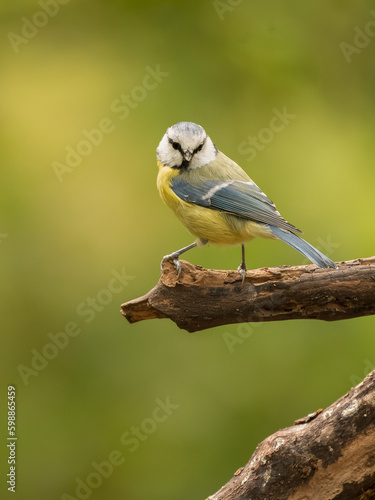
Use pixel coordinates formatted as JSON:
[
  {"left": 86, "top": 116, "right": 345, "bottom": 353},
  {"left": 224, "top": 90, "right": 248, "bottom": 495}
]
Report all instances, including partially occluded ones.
[{"left": 0, "top": 0, "right": 375, "bottom": 500}]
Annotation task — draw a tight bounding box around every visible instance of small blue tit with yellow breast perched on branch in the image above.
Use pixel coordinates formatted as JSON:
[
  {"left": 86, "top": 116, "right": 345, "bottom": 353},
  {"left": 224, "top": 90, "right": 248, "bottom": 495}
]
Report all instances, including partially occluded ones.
[{"left": 156, "top": 118, "right": 336, "bottom": 284}]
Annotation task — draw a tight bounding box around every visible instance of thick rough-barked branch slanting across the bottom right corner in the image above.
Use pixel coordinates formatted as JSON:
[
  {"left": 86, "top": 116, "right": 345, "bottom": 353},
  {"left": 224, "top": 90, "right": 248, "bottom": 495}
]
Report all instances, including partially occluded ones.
[{"left": 207, "top": 370, "right": 375, "bottom": 500}]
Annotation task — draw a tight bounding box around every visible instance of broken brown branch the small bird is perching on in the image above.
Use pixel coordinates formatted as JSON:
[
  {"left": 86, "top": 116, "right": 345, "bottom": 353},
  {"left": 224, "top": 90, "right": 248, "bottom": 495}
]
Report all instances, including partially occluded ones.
[{"left": 121, "top": 257, "right": 375, "bottom": 332}]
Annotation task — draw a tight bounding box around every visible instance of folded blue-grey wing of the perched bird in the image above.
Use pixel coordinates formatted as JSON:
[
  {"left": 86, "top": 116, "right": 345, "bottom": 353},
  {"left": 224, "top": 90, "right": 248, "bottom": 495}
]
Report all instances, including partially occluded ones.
[{"left": 171, "top": 176, "right": 302, "bottom": 233}]
